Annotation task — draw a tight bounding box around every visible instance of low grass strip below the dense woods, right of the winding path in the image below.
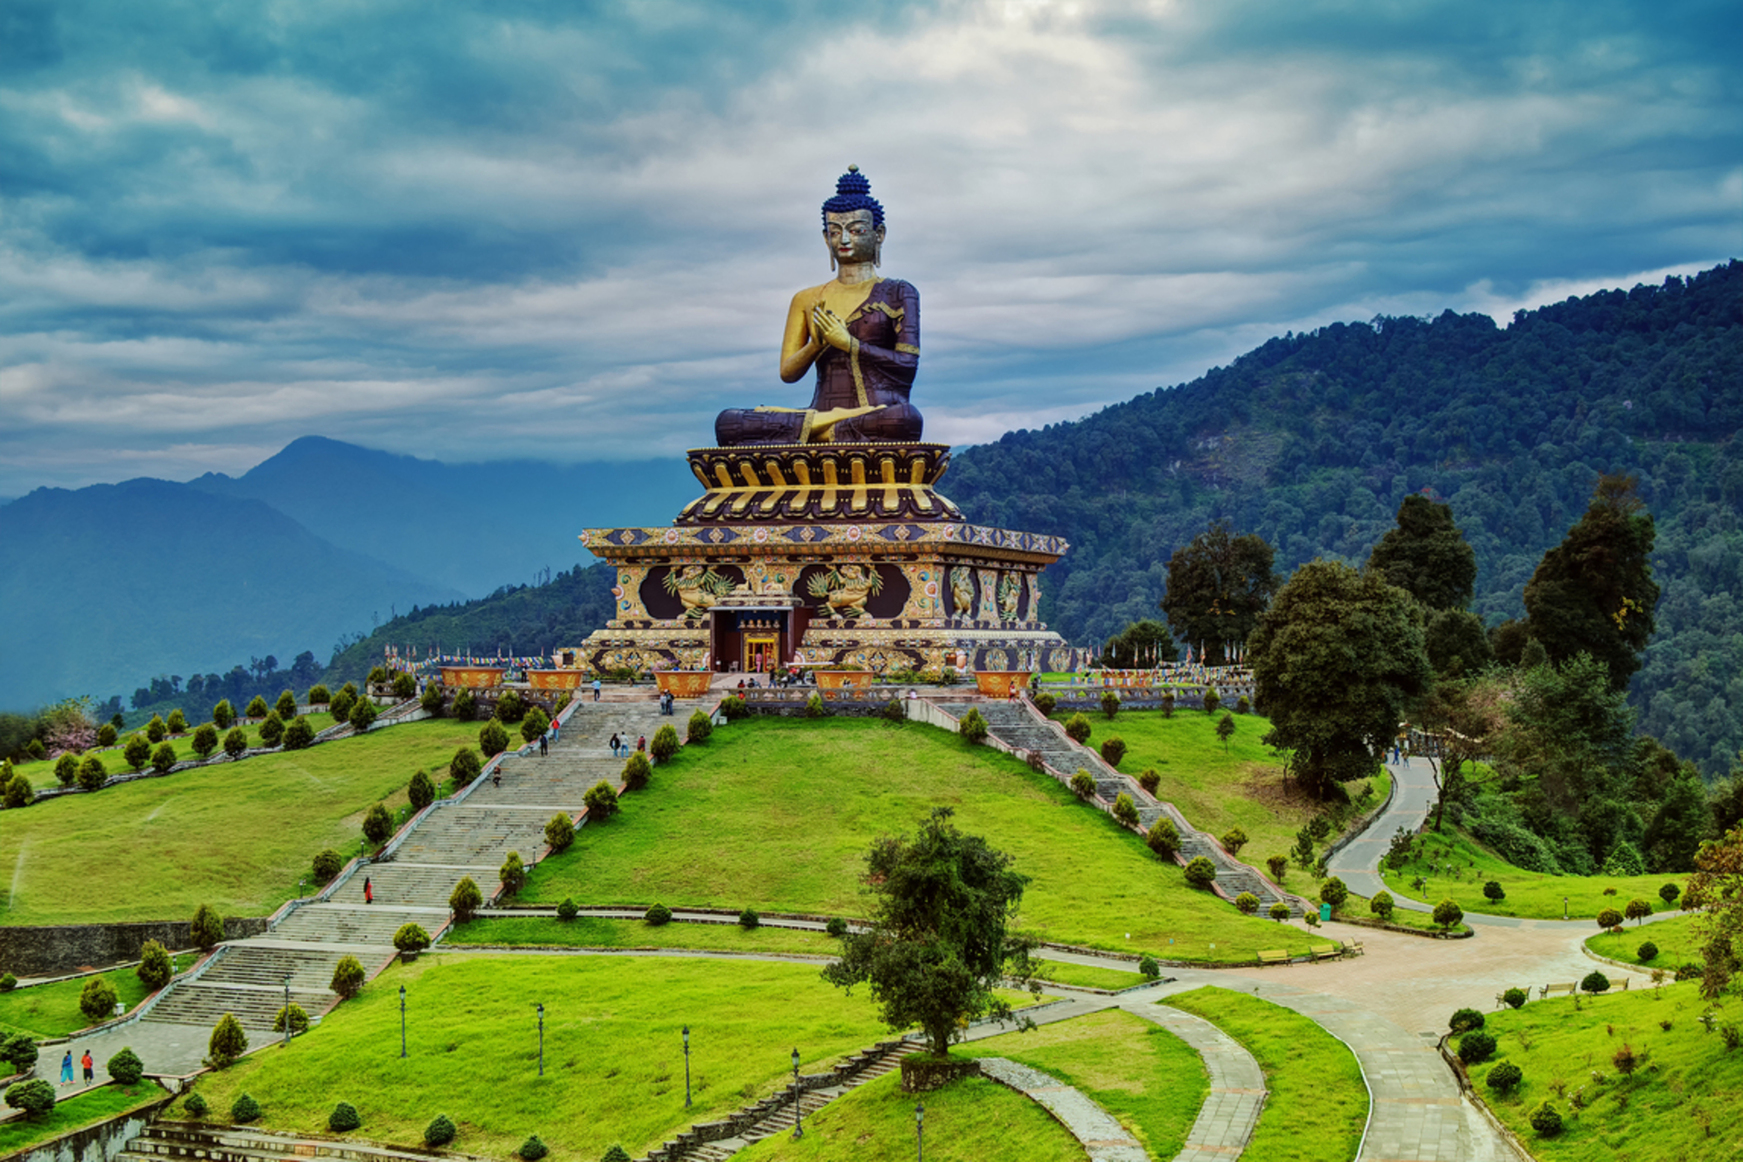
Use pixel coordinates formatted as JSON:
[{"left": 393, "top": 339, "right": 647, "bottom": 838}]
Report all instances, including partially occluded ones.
[{"left": 1380, "top": 824, "right": 1687, "bottom": 920}]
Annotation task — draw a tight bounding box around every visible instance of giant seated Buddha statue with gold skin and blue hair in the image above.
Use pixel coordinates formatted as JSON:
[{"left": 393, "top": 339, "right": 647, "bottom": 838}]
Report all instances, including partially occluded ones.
[{"left": 715, "top": 166, "right": 922, "bottom": 448}]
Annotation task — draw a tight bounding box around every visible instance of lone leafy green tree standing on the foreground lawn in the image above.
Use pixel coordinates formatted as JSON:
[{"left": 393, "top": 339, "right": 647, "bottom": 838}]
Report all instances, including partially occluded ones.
[{"left": 823, "top": 807, "right": 1039, "bottom": 1057}]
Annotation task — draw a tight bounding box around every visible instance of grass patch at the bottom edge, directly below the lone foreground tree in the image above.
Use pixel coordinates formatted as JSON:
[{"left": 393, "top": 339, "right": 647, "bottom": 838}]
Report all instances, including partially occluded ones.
[{"left": 728, "top": 1073, "right": 1084, "bottom": 1162}]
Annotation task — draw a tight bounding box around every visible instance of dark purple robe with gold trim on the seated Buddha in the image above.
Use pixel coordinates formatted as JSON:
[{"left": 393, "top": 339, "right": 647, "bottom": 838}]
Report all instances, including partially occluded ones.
[{"left": 715, "top": 279, "right": 922, "bottom": 448}]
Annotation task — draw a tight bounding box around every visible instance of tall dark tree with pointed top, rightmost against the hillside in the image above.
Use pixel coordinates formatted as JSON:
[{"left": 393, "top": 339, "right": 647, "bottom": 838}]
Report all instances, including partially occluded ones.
[{"left": 1525, "top": 476, "right": 1659, "bottom": 690}]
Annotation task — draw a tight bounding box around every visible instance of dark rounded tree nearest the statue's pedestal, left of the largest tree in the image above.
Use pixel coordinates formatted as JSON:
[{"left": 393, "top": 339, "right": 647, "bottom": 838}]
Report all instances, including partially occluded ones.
[{"left": 1163, "top": 521, "right": 1281, "bottom": 665}]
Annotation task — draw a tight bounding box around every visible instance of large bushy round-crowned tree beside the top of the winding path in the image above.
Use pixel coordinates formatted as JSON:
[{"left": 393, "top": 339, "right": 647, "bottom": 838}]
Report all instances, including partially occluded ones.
[{"left": 1250, "top": 559, "right": 1433, "bottom": 798}]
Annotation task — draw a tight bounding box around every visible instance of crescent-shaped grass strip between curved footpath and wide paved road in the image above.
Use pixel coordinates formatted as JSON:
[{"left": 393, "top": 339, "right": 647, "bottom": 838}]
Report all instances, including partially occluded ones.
[{"left": 1168, "top": 988, "right": 1368, "bottom": 1162}]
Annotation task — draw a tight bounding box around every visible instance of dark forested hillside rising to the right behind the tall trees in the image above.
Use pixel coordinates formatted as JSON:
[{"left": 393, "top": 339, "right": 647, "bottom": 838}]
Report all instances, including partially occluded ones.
[{"left": 945, "top": 261, "right": 1743, "bottom": 777}]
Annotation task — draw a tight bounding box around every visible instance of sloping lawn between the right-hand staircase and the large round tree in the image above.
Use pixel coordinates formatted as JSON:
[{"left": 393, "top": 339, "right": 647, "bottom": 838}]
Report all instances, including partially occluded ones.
[{"left": 1053, "top": 707, "right": 1391, "bottom": 869}]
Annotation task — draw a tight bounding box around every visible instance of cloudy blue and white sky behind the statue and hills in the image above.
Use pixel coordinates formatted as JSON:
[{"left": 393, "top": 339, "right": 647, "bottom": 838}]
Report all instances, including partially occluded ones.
[{"left": 0, "top": 0, "right": 1743, "bottom": 497}]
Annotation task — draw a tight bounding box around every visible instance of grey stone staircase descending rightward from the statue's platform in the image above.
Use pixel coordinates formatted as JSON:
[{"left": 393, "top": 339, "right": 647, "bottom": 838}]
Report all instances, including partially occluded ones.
[{"left": 962, "top": 702, "right": 1304, "bottom": 916}]
